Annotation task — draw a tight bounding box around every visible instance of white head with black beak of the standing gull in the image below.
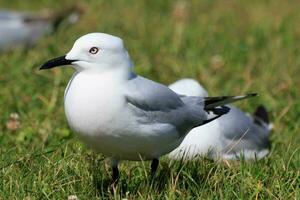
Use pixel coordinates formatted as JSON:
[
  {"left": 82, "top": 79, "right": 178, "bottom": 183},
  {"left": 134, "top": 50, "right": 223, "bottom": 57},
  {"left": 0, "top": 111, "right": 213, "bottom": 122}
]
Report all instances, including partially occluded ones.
[{"left": 40, "top": 33, "right": 132, "bottom": 71}]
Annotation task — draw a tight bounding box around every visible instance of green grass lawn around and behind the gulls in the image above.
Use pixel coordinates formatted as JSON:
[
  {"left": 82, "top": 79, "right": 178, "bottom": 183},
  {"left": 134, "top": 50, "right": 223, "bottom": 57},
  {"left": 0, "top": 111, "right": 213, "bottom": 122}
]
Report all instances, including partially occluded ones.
[{"left": 0, "top": 0, "right": 300, "bottom": 200}]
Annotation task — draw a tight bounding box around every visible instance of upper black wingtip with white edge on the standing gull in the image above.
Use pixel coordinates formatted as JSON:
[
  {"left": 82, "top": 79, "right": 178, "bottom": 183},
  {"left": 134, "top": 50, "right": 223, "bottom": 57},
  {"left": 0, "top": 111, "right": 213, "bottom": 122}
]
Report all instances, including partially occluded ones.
[{"left": 204, "top": 93, "right": 257, "bottom": 111}]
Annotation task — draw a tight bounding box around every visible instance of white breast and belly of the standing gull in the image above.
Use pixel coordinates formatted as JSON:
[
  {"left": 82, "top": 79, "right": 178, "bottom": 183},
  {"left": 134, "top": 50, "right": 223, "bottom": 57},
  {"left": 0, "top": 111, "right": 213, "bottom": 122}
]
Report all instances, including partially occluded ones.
[{"left": 65, "top": 72, "right": 182, "bottom": 160}]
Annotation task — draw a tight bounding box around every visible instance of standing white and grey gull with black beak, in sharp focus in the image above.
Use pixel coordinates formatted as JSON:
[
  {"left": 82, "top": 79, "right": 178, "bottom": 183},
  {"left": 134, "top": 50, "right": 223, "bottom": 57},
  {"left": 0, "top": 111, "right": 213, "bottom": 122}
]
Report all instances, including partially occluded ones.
[{"left": 41, "top": 33, "right": 256, "bottom": 181}]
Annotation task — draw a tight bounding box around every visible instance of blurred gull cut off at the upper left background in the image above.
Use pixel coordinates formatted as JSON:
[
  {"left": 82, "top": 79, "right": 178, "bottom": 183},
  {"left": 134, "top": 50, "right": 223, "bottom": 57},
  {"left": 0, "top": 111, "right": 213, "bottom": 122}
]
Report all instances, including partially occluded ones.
[{"left": 0, "top": 6, "right": 83, "bottom": 51}]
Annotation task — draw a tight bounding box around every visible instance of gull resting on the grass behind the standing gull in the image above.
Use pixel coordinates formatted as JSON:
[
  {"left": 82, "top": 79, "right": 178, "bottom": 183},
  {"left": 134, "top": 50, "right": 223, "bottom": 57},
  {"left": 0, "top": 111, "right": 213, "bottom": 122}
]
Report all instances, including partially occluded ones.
[{"left": 168, "top": 79, "right": 272, "bottom": 160}]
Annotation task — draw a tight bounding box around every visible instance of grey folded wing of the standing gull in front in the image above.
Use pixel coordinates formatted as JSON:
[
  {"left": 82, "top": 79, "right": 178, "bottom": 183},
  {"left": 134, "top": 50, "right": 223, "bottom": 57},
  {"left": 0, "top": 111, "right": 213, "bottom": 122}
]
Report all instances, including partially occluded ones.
[{"left": 125, "top": 76, "right": 206, "bottom": 134}]
